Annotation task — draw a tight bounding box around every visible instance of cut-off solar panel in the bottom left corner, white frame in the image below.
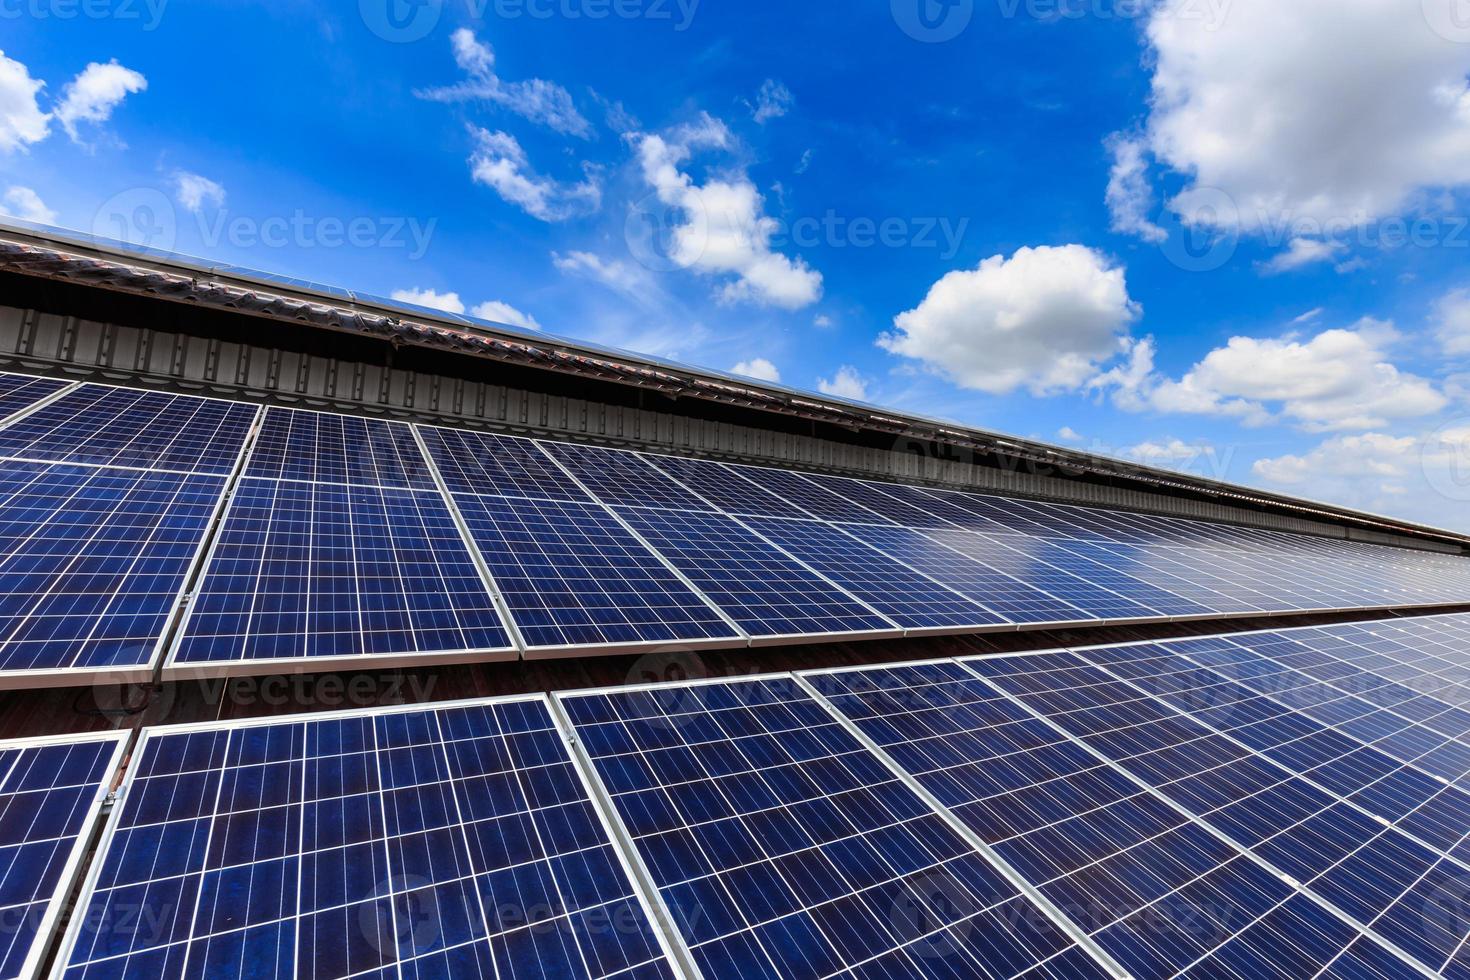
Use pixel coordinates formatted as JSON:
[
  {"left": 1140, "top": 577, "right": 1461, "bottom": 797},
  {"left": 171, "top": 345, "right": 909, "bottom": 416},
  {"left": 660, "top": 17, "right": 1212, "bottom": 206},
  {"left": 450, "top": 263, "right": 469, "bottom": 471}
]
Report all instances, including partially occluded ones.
[{"left": 0, "top": 735, "right": 119, "bottom": 980}]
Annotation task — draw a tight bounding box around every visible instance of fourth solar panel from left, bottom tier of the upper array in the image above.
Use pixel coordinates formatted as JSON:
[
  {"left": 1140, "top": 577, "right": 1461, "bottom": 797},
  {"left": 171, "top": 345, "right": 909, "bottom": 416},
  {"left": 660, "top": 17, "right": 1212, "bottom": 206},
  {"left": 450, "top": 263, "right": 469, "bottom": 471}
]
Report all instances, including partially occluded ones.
[{"left": 617, "top": 507, "right": 894, "bottom": 636}]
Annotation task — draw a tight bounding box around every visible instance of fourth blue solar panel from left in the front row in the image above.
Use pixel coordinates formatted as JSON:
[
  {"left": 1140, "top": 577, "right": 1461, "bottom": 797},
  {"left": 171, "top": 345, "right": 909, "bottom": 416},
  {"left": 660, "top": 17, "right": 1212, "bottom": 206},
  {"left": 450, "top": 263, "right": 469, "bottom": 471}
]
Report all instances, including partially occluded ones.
[{"left": 803, "top": 661, "right": 1355, "bottom": 977}]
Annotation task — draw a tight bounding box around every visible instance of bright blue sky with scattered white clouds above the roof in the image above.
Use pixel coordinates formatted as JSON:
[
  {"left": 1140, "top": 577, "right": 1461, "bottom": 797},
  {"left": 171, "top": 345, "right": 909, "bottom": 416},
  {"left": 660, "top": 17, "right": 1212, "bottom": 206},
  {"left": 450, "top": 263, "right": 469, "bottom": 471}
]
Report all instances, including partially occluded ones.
[{"left": 0, "top": 0, "right": 1470, "bottom": 530}]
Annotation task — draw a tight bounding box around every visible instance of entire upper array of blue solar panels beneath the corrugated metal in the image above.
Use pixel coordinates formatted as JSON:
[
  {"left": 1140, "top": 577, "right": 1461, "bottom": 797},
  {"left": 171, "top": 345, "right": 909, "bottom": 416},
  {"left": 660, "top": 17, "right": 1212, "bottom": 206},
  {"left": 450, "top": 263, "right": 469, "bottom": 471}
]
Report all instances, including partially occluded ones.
[{"left": 0, "top": 367, "right": 1470, "bottom": 686}]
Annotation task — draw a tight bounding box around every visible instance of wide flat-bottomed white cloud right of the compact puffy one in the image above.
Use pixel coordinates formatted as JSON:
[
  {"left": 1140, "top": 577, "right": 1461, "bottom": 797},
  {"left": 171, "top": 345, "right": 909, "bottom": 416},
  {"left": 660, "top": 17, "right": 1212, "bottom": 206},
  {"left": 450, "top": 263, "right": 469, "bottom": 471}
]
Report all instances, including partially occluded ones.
[{"left": 1095, "top": 319, "right": 1448, "bottom": 432}]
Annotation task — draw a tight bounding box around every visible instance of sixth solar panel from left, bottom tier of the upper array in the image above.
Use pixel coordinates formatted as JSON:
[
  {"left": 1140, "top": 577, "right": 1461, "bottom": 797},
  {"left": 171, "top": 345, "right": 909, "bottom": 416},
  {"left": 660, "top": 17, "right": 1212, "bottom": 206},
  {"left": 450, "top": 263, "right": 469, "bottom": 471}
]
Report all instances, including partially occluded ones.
[{"left": 838, "top": 525, "right": 1100, "bottom": 627}]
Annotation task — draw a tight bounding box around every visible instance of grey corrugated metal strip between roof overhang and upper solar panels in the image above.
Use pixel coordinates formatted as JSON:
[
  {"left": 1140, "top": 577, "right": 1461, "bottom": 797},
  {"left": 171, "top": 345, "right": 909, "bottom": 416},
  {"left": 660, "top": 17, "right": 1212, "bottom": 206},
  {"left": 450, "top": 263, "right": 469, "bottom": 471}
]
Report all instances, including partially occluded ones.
[{"left": 0, "top": 307, "right": 1458, "bottom": 552}]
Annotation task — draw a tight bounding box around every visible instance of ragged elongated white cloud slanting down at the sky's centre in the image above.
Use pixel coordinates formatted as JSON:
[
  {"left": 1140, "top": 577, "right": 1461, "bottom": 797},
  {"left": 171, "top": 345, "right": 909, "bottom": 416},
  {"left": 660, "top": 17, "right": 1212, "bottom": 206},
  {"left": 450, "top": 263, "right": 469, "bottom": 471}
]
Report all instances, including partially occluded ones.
[{"left": 637, "top": 115, "right": 822, "bottom": 310}]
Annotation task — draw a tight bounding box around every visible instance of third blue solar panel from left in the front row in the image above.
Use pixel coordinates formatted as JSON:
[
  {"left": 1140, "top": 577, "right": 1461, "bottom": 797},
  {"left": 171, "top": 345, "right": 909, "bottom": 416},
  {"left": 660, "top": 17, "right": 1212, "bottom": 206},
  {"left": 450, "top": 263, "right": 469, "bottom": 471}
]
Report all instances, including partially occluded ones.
[{"left": 562, "top": 680, "right": 1107, "bottom": 980}]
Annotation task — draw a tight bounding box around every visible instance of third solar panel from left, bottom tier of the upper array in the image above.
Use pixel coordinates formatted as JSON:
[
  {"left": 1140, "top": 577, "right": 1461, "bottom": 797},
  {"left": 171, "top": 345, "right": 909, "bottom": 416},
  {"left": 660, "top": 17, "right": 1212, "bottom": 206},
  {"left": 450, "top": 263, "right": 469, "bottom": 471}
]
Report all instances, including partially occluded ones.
[{"left": 456, "top": 494, "right": 739, "bottom": 646}]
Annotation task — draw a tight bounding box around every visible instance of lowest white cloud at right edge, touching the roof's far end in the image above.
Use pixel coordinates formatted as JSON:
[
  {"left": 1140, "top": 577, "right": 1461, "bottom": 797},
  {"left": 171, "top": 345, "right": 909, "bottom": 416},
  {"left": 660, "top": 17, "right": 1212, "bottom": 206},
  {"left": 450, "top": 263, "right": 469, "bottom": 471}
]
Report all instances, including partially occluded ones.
[{"left": 1254, "top": 425, "right": 1470, "bottom": 532}]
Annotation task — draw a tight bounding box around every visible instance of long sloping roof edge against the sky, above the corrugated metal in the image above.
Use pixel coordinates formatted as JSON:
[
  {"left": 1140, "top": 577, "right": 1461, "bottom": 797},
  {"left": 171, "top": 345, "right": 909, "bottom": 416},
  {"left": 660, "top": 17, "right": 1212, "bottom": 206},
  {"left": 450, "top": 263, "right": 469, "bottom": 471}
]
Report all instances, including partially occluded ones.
[{"left": 0, "top": 215, "right": 1470, "bottom": 547}]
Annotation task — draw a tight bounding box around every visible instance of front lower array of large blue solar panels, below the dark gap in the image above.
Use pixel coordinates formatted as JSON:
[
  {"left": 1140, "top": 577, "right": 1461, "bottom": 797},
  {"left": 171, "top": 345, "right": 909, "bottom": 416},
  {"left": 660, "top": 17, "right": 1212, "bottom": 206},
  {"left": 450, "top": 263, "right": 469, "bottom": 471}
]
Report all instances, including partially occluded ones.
[{"left": 45, "top": 614, "right": 1470, "bottom": 980}]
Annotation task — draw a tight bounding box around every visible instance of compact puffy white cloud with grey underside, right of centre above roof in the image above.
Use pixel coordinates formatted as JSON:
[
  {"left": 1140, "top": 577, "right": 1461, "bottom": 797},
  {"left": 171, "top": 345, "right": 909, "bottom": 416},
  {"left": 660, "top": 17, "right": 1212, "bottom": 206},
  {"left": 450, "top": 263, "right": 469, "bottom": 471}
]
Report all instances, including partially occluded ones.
[{"left": 878, "top": 245, "right": 1141, "bottom": 395}]
